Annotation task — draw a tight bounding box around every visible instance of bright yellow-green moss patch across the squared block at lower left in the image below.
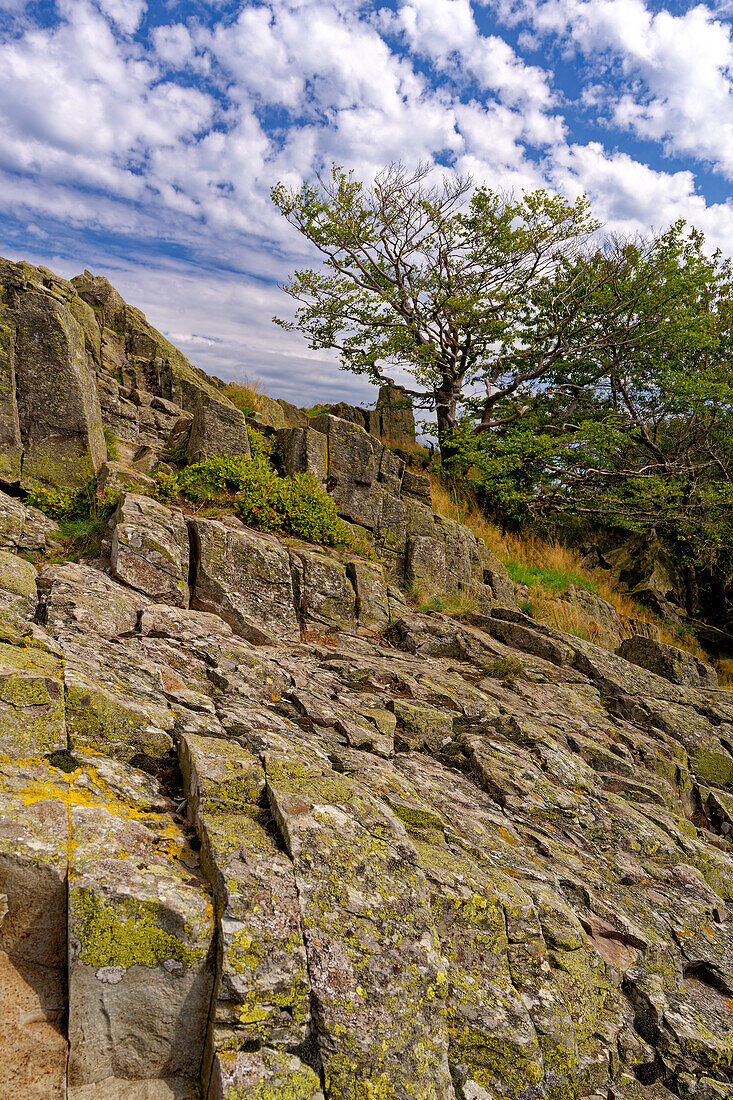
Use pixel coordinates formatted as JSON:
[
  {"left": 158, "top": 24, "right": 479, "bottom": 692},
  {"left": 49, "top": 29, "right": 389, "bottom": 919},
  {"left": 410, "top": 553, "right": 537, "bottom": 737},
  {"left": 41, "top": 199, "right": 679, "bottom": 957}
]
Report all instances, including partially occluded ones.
[{"left": 72, "top": 889, "right": 204, "bottom": 970}]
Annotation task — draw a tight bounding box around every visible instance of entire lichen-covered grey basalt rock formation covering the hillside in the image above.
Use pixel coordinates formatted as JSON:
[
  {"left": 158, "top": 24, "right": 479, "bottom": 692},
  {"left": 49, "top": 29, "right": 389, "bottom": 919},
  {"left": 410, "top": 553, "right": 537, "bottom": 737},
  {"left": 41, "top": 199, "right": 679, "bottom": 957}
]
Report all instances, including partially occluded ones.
[{"left": 0, "top": 259, "right": 733, "bottom": 1100}]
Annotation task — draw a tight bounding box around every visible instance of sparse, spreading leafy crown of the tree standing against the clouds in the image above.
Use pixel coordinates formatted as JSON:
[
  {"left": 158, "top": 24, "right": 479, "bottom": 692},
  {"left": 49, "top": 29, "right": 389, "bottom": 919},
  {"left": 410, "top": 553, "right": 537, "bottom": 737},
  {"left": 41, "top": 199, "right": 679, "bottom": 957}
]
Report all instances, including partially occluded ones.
[{"left": 268, "top": 165, "right": 616, "bottom": 451}]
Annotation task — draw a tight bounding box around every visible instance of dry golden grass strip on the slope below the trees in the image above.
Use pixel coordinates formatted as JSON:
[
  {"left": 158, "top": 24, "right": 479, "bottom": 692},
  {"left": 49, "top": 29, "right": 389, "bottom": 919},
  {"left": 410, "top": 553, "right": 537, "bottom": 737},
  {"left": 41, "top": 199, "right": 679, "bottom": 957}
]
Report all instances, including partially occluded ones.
[{"left": 431, "top": 479, "right": 708, "bottom": 660}]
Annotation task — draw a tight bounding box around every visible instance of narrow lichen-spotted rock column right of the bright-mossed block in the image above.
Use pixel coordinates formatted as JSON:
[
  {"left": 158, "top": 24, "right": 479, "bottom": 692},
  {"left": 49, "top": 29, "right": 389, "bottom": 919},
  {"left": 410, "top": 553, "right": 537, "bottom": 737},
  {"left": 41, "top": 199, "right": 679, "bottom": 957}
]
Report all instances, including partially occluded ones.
[{"left": 180, "top": 735, "right": 318, "bottom": 1100}]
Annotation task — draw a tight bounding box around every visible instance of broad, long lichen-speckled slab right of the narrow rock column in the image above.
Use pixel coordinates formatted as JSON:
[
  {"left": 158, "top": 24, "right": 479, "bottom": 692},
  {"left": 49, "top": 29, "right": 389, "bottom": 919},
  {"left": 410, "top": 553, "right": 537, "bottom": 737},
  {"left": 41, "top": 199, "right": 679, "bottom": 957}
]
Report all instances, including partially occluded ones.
[{"left": 265, "top": 752, "right": 455, "bottom": 1100}]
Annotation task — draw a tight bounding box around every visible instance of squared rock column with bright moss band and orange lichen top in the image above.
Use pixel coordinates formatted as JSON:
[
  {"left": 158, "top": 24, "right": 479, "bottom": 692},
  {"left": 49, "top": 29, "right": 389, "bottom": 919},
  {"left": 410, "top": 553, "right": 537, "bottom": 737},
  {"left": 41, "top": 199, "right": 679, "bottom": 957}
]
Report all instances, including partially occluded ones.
[{"left": 68, "top": 765, "right": 214, "bottom": 1088}]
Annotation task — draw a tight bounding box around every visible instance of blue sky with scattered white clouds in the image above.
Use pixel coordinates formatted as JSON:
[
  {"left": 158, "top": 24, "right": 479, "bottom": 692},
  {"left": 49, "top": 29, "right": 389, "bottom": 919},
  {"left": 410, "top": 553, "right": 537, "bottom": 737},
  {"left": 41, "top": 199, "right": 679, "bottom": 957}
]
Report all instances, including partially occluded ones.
[{"left": 0, "top": 0, "right": 733, "bottom": 405}]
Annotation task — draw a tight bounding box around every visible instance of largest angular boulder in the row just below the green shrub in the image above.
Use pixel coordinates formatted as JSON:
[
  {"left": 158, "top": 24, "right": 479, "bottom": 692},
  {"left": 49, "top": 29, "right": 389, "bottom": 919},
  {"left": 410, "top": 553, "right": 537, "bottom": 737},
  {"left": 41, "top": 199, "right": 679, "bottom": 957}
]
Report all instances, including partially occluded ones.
[{"left": 190, "top": 518, "right": 300, "bottom": 645}]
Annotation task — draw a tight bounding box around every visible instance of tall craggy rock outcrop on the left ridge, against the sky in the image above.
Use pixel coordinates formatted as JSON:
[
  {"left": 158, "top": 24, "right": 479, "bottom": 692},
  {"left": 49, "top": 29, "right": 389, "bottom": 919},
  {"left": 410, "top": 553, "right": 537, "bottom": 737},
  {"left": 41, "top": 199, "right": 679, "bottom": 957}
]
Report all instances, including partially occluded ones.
[{"left": 0, "top": 260, "right": 249, "bottom": 488}]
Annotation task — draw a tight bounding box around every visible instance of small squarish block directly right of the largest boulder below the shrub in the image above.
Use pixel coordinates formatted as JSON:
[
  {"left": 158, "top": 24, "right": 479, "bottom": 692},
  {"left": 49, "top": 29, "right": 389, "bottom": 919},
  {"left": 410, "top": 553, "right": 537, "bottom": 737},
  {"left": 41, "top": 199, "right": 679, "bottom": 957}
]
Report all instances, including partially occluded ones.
[{"left": 291, "top": 550, "right": 357, "bottom": 630}]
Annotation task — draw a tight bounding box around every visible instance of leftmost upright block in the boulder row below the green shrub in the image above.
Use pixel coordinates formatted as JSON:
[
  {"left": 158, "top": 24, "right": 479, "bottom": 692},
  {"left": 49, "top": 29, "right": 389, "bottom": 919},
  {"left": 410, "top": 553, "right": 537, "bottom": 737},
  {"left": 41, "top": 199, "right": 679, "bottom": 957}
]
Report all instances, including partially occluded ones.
[{"left": 110, "top": 493, "right": 188, "bottom": 607}]
